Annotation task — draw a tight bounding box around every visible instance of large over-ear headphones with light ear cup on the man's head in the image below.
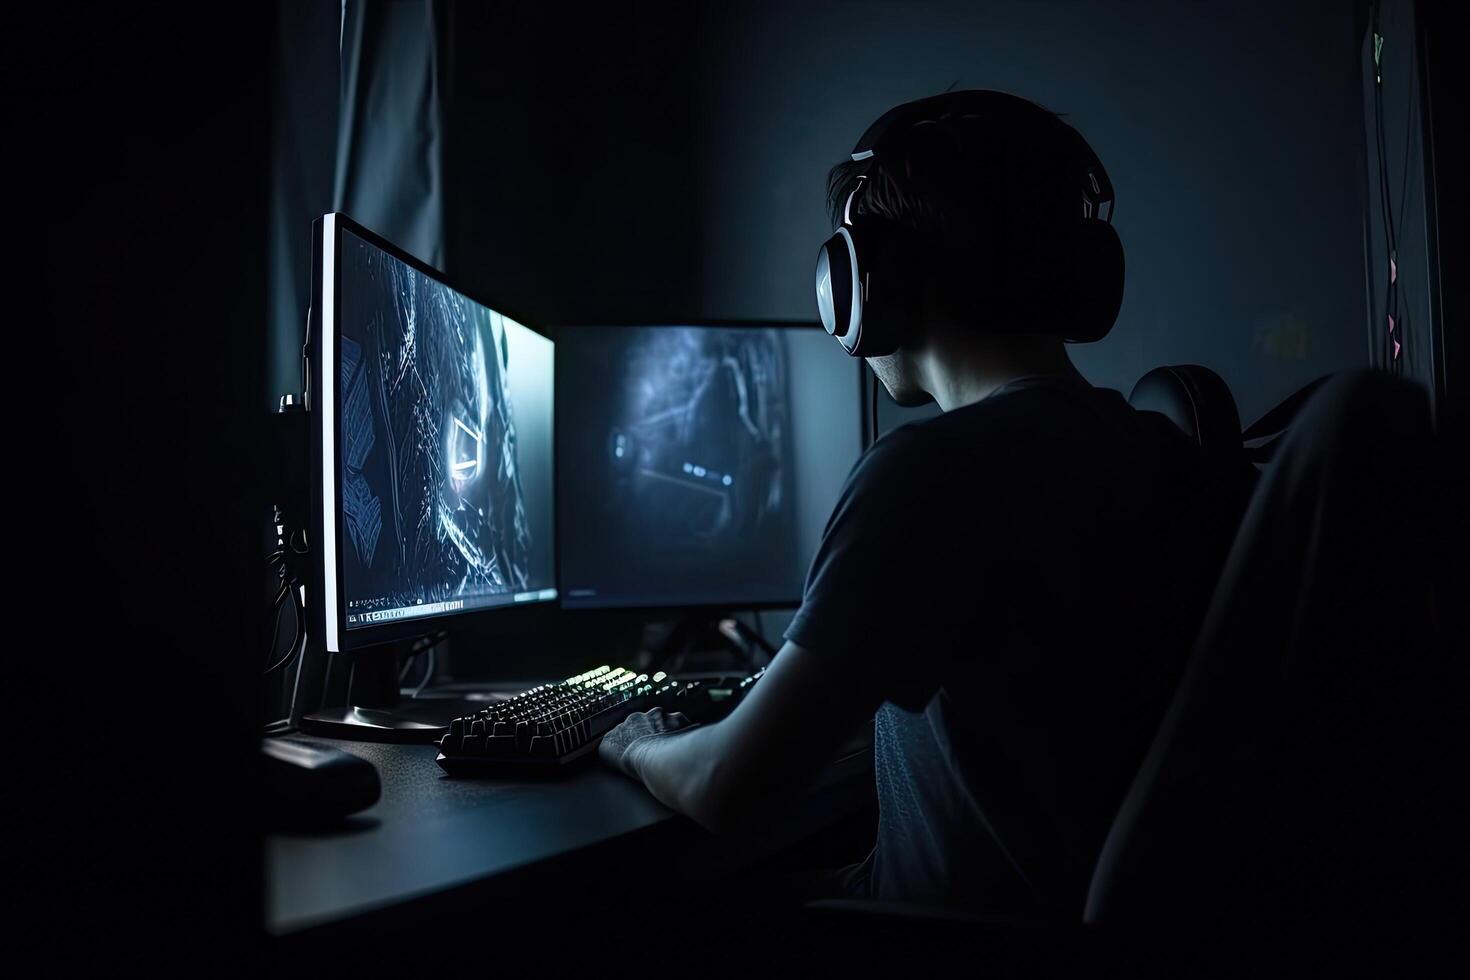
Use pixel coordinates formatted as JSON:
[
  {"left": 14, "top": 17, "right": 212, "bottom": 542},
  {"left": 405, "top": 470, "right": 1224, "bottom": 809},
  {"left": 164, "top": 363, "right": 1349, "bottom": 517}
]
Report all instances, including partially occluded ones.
[{"left": 816, "top": 90, "right": 1123, "bottom": 357}]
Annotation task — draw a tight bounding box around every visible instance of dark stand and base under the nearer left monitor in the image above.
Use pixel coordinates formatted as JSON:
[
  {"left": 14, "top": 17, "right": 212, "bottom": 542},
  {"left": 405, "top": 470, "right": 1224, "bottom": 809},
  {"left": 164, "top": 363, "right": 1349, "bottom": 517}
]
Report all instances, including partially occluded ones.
[{"left": 297, "top": 637, "right": 503, "bottom": 742}]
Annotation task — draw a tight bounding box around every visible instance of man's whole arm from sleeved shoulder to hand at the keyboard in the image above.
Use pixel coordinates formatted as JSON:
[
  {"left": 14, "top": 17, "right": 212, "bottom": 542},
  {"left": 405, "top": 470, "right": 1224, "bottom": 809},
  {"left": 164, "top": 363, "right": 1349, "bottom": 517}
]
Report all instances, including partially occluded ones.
[{"left": 601, "top": 426, "right": 958, "bottom": 830}]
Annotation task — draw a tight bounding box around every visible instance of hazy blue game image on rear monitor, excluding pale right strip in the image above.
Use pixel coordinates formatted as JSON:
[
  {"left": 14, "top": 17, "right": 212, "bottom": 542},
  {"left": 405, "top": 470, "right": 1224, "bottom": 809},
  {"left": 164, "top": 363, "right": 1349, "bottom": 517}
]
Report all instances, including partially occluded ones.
[{"left": 563, "top": 326, "right": 794, "bottom": 599}]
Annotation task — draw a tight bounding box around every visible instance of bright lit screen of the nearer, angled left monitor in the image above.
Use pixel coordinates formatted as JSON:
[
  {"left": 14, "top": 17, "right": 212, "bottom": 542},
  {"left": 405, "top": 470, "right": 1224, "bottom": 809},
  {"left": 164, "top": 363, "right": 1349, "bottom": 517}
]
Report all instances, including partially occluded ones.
[{"left": 323, "top": 214, "right": 557, "bottom": 652}]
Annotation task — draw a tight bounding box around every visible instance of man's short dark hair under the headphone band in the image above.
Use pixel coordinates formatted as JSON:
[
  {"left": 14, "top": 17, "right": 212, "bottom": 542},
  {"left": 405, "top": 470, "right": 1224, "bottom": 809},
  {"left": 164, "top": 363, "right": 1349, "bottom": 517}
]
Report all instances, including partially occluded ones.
[{"left": 828, "top": 110, "right": 1082, "bottom": 323}]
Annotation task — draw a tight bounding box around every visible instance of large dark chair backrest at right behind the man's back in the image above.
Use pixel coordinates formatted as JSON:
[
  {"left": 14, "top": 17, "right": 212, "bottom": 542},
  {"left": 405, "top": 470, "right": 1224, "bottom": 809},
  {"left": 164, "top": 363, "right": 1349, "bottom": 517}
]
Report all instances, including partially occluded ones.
[{"left": 1085, "top": 372, "right": 1467, "bottom": 955}]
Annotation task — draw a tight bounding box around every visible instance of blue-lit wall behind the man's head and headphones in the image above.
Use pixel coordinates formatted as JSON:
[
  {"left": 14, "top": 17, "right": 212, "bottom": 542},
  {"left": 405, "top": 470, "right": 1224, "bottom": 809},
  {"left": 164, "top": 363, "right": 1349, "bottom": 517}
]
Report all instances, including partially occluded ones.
[{"left": 700, "top": 0, "right": 1367, "bottom": 425}]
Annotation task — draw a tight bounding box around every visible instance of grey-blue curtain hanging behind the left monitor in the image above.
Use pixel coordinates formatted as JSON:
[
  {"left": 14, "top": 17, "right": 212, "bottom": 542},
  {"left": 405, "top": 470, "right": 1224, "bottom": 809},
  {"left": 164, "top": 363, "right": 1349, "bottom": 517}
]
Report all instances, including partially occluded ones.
[{"left": 266, "top": 0, "right": 448, "bottom": 408}]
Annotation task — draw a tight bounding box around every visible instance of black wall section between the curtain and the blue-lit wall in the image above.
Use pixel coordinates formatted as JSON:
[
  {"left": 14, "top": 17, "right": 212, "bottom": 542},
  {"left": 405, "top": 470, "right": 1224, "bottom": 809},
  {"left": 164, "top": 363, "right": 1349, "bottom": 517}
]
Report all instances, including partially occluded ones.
[{"left": 444, "top": 1, "right": 701, "bottom": 323}]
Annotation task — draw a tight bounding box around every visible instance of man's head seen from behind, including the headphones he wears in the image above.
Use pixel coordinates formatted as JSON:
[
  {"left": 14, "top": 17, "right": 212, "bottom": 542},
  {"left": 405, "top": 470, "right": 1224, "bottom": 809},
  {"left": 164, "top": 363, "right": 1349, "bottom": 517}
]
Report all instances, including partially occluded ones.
[{"left": 819, "top": 93, "right": 1122, "bottom": 404}]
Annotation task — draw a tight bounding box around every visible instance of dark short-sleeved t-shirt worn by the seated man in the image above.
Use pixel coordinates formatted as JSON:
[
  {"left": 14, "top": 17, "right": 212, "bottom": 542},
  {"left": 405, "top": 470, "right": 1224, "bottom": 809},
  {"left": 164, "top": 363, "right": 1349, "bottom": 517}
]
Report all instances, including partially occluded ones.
[{"left": 786, "top": 371, "right": 1251, "bottom": 914}]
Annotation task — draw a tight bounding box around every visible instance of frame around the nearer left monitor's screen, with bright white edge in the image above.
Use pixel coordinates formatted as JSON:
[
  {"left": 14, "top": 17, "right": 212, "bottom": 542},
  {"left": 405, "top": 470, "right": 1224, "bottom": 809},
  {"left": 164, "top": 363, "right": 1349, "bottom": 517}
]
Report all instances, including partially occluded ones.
[{"left": 307, "top": 212, "right": 560, "bottom": 652}]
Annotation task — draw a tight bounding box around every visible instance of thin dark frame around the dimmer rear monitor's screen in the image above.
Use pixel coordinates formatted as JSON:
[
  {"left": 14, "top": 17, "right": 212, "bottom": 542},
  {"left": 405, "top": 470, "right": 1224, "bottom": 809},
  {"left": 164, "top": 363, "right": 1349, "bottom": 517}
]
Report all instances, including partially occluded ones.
[{"left": 551, "top": 317, "right": 870, "bottom": 614}]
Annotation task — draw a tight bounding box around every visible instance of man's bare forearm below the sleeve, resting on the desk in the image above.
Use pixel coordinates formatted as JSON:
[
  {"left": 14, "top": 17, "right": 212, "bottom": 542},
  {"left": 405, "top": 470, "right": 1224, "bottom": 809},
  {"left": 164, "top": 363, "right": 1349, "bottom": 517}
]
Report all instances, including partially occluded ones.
[{"left": 608, "top": 642, "right": 882, "bottom": 830}]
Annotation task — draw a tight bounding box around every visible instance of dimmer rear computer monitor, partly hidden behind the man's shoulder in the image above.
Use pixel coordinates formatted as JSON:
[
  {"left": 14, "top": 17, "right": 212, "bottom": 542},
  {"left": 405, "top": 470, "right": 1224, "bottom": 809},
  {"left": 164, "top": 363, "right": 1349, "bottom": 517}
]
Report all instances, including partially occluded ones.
[{"left": 557, "top": 323, "right": 864, "bottom": 610}]
